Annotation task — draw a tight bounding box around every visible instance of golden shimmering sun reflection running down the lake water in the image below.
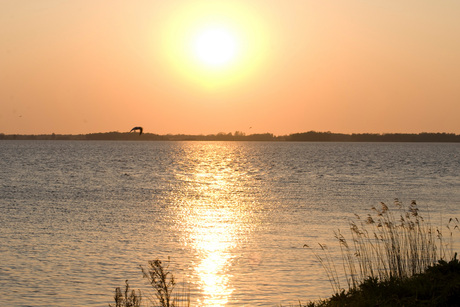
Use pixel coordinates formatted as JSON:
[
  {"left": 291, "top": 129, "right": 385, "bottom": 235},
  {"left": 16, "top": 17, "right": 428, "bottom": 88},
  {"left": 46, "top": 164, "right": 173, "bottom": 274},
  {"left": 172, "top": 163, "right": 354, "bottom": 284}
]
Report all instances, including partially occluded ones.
[{"left": 172, "top": 143, "right": 256, "bottom": 306}]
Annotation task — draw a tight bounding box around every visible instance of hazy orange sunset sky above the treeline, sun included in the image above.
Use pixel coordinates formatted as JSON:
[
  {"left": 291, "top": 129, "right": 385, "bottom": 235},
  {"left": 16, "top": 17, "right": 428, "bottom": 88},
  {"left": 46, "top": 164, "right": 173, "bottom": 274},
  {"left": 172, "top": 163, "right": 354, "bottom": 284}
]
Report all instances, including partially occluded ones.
[{"left": 0, "top": 0, "right": 460, "bottom": 135}]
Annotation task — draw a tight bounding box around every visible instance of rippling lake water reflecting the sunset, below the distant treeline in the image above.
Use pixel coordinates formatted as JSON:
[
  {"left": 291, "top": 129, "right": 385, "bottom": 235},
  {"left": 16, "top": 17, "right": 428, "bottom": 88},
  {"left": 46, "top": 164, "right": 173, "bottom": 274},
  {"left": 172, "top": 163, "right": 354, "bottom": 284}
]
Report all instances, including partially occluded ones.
[{"left": 0, "top": 141, "right": 460, "bottom": 306}]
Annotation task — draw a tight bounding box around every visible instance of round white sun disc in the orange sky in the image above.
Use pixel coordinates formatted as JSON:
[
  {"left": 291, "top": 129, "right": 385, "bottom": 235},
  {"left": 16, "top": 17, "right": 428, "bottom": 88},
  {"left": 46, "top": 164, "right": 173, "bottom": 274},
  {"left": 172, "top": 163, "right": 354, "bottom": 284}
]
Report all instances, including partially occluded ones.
[{"left": 193, "top": 27, "right": 240, "bottom": 68}]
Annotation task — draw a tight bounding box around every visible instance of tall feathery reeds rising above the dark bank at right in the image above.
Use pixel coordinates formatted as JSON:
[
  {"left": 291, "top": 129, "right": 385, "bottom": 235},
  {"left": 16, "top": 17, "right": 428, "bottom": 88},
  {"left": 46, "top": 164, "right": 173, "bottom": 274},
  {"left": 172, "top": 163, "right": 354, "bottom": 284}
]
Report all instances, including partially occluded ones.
[{"left": 304, "top": 200, "right": 458, "bottom": 293}]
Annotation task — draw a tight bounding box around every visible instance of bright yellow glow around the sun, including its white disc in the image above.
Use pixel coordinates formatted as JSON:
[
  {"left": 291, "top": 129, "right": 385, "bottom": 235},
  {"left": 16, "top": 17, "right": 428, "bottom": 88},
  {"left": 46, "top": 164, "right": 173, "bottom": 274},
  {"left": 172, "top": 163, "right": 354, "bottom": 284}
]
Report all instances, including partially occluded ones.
[{"left": 161, "top": 1, "right": 269, "bottom": 89}]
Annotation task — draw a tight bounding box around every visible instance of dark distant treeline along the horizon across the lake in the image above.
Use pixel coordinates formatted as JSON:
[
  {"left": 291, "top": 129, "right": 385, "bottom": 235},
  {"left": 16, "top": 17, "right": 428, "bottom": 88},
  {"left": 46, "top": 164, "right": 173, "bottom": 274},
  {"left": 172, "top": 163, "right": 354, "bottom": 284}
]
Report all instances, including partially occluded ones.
[{"left": 0, "top": 131, "right": 460, "bottom": 142}]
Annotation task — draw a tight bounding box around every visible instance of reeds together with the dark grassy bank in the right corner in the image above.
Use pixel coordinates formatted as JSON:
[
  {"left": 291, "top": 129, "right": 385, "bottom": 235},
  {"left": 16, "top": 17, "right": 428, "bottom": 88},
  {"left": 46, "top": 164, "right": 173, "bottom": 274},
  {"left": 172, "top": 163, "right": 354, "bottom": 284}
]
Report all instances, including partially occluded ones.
[{"left": 305, "top": 200, "right": 460, "bottom": 307}]
